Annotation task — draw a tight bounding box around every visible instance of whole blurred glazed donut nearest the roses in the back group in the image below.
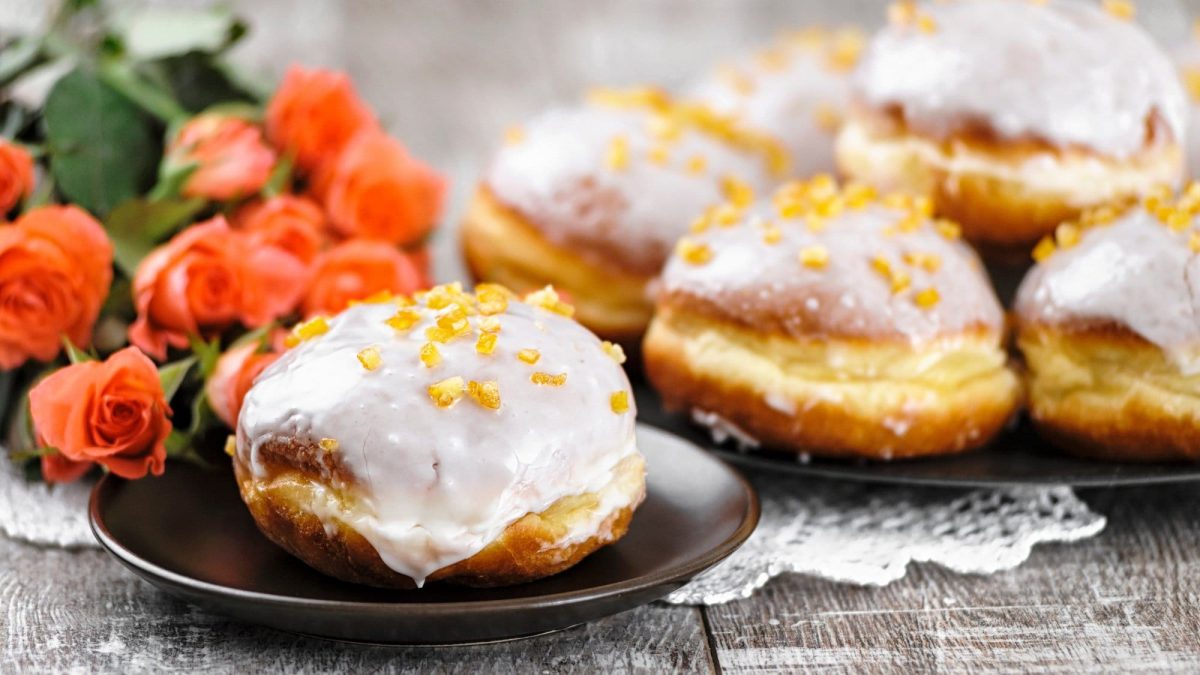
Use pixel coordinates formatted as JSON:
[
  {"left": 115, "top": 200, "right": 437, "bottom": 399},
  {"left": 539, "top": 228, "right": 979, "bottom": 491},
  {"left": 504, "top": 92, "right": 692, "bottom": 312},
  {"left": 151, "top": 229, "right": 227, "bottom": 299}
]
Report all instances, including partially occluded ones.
[{"left": 462, "top": 89, "right": 786, "bottom": 344}]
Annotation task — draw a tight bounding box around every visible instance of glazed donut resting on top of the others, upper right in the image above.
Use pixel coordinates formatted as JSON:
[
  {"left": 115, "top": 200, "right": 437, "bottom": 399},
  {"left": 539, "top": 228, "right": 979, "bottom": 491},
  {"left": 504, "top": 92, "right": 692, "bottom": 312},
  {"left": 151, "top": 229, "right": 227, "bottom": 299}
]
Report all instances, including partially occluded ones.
[{"left": 836, "top": 0, "right": 1186, "bottom": 257}]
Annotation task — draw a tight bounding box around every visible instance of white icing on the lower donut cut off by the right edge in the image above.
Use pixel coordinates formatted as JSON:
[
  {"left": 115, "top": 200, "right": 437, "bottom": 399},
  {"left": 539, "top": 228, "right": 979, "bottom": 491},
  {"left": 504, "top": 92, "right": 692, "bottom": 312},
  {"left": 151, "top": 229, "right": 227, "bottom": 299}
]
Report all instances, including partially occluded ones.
[{"left": 1015, "top": 208, "right": 1200, "bottom": 374}]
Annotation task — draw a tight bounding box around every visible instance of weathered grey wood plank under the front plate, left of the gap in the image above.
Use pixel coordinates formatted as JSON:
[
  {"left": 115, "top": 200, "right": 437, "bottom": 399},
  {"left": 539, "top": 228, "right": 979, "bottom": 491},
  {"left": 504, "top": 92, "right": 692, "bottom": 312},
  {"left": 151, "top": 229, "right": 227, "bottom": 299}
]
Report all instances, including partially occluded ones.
[{"left": 0, "top": 537, "right": 713, "bottom": 673}]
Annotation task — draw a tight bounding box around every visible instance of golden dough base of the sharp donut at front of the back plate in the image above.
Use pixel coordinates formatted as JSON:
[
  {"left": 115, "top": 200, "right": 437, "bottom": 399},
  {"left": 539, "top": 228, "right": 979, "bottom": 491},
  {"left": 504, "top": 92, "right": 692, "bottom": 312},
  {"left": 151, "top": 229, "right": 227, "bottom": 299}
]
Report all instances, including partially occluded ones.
[{"left": 643, "top": 305, "right": 1021, "bottom": 460}]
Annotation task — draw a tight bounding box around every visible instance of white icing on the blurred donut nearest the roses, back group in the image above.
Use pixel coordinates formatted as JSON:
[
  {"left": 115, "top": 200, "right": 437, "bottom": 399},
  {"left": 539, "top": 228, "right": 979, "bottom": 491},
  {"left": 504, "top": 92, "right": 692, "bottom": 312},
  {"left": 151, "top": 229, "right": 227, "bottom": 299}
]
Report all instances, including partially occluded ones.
[{"left": 485, "top": 106, "right": 770, "bottom": 276}]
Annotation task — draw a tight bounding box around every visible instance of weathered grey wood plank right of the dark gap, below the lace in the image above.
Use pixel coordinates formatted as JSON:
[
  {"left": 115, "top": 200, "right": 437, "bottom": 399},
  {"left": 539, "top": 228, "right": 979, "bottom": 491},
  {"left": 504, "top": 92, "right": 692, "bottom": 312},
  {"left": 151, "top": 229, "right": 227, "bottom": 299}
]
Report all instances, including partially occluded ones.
[{"left": 707, "top": 485, "right": 1200, "bottom": 673}]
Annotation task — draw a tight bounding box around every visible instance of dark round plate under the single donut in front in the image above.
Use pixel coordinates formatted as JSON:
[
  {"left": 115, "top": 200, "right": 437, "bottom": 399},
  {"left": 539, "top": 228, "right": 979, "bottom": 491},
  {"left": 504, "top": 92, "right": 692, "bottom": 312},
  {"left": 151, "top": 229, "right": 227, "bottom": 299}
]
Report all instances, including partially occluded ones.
[{"left": 90, "top": 426, "right": 758, "bottom": 644}]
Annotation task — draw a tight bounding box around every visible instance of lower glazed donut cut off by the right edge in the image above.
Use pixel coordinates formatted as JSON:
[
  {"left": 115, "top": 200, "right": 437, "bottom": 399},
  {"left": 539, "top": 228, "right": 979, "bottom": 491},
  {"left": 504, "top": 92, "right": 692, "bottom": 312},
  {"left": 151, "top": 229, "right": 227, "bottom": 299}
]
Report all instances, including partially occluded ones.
[{"left": 1015, "top": 184, "right": 1200, "bottom": 461}]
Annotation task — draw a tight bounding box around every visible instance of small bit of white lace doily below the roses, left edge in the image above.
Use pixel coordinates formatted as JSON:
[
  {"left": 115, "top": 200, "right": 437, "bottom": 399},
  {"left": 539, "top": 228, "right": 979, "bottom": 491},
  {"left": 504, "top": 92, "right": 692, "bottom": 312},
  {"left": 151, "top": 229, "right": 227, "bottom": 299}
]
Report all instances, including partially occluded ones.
[{"left": 0, "top": 448, "right": 98, "bottom": 548}]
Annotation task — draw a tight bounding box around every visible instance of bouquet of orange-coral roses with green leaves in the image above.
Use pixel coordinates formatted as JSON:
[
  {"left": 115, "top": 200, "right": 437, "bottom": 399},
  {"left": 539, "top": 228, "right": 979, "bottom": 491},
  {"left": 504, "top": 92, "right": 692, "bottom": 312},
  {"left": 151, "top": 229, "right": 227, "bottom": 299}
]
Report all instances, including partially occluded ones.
[{"left": 0, "top": 0, "right": 445, "bottom": 482}]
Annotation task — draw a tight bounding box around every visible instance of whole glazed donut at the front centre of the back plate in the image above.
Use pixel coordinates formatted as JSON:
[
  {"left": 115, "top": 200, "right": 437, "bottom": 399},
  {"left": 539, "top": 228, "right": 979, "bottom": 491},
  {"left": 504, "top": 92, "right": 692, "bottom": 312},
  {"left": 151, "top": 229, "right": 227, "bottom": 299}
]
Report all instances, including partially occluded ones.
[{"left": 643, "top": 175, "right": 1020, "bottom": 460}]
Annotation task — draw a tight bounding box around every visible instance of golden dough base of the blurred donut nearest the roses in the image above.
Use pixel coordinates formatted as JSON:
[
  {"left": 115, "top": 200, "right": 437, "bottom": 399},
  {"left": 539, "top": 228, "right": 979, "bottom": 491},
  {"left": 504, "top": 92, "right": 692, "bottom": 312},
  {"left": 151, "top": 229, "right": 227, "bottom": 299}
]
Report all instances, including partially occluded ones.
[{"left": 461, "top": 186, "right": 654, "bottom": 345}]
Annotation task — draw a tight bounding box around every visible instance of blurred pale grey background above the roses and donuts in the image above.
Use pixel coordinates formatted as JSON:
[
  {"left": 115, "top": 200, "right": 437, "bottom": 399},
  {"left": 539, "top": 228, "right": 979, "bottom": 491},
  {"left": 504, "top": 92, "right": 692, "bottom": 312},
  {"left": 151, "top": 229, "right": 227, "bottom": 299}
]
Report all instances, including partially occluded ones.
[{"left": 0, "top": 0, "right": 1200, "bottom": 280}]
